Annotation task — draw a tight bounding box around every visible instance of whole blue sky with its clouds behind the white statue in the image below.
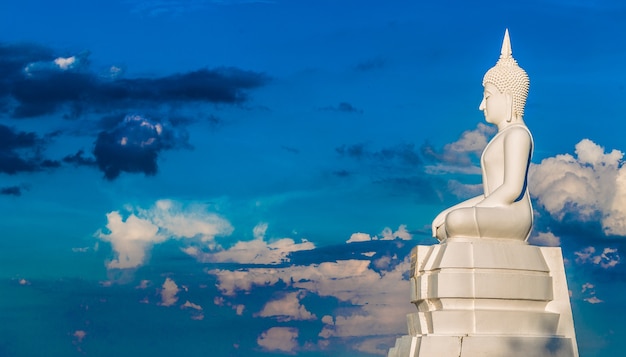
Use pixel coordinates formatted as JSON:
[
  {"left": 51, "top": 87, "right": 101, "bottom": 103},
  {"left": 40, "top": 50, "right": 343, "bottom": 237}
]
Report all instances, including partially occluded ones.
[{"left": 0, "top": 0, "right": 626, "bottom": 356}]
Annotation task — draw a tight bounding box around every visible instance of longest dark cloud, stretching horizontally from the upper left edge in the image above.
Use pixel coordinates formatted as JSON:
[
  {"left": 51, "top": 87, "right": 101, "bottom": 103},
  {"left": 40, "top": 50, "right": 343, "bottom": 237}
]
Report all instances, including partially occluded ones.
[{"left": 0, "top": 45, "right": 268, "bottom": 118}]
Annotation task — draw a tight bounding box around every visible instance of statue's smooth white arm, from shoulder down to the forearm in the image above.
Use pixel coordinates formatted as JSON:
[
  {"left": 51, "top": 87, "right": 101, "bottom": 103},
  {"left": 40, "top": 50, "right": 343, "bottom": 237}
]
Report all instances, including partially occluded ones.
[{"left": 476, "top": 128, "right": 532, "bottom": 207}]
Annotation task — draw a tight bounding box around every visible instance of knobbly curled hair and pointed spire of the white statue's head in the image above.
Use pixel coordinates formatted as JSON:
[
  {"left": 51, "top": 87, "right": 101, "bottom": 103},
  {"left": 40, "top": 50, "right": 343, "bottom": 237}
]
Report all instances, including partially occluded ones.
[{"left": 483, "top": 29, "right": 530, "bottom": 118}]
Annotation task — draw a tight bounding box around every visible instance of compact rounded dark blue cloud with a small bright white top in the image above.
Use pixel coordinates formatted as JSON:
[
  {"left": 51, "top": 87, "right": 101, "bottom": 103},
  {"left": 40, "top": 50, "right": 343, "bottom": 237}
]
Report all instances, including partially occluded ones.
[{"left": 91, "top": 115, "right": 189, "bottom": 180}]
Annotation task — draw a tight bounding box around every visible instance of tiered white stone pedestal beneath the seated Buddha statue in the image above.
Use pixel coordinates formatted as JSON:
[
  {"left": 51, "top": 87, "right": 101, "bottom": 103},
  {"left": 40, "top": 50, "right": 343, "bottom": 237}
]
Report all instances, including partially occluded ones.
[{"left": 388, "top": 239, "right": 578, "bottom": 357}]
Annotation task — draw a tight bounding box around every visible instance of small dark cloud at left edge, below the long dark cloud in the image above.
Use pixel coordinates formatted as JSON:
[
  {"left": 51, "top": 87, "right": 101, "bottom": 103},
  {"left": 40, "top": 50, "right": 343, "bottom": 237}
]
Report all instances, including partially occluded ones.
[{"left": 0, "top": 124, "right": 60, "bottom": 175}]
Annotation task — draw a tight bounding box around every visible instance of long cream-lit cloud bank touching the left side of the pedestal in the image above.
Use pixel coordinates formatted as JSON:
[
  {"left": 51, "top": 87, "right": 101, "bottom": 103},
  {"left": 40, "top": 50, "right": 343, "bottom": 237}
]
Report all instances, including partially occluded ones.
[{"left": 208, "top": 253, "right": 414, "bottom": 344}]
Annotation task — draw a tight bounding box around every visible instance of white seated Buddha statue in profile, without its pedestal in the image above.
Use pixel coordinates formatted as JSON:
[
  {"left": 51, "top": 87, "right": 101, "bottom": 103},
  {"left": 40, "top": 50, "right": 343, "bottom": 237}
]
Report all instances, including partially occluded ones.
[{"left": 432, "top": 30, "right": 533, "bottom": 242}]
